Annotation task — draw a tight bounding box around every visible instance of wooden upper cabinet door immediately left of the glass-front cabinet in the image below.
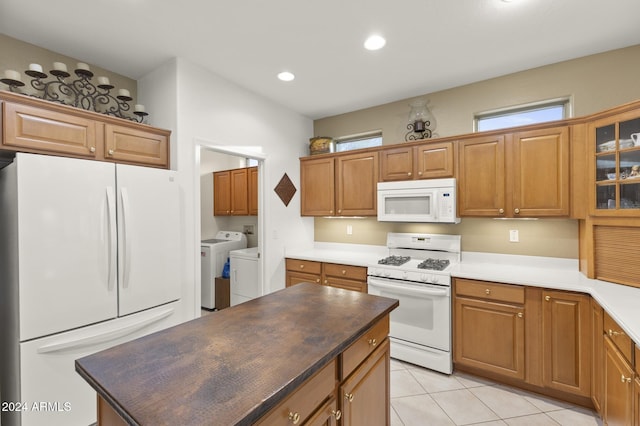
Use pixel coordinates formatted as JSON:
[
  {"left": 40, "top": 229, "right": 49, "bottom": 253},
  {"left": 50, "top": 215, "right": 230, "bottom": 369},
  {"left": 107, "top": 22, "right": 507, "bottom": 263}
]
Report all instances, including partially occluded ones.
[{"left": 507, "top": 126, "right": 569, "bottom": 217}]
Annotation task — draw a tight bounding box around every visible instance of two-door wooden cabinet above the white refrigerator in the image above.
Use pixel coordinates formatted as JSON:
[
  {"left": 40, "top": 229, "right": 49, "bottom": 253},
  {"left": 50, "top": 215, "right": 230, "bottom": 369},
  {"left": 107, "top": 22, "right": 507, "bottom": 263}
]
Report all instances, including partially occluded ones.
[{"left": 0, "top": 93, "right": 171, "bottom": 168}]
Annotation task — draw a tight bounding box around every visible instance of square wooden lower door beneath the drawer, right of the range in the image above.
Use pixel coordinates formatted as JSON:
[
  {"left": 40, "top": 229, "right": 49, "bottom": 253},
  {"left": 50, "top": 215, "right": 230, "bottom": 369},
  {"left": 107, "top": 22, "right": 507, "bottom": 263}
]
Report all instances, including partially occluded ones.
[{"left": 453, "top": 297, "right": 525, "bottom": 380}]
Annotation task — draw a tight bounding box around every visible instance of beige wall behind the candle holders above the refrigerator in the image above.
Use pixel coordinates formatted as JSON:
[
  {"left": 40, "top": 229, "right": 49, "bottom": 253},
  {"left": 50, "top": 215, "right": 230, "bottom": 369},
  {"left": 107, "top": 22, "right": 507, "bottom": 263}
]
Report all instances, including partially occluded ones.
[{"left": 0, "top": 34, "right": 136, "bottom": 102}]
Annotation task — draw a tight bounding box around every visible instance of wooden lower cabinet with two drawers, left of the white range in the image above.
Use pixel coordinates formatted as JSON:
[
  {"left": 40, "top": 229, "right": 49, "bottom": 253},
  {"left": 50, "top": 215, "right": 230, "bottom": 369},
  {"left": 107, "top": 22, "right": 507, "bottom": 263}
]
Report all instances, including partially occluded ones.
[{"left": 285, "top": 259, "right": 367, "bottom": 293}]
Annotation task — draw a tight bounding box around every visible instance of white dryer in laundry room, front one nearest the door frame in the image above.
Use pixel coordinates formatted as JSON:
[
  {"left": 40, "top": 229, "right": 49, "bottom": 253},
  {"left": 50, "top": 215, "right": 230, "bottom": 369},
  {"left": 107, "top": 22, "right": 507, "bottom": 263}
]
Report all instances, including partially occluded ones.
[{"left": 229, "top": 247, "right": 262, "bottom": 306}]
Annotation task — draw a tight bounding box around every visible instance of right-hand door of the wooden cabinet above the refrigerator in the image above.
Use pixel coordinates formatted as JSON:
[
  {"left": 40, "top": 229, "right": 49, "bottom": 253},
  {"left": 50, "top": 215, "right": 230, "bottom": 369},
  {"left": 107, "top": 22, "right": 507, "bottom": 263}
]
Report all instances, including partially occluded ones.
[{"left": 104, "top": 124, "right": 169, "bottom": 168}]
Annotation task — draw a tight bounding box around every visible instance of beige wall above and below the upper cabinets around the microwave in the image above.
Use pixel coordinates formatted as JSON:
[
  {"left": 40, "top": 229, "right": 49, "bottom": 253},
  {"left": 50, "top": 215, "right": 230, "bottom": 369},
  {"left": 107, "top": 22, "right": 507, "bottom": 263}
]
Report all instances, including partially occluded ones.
[{"left": 314, "top": 45, "right": 640, "bottom": 258}]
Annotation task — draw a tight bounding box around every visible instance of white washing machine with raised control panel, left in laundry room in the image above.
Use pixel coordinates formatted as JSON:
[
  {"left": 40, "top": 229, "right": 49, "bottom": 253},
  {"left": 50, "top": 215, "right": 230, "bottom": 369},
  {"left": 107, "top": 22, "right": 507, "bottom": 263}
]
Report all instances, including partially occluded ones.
[{"left": 200, "top": 231, "right": 247, "bottom": 309}]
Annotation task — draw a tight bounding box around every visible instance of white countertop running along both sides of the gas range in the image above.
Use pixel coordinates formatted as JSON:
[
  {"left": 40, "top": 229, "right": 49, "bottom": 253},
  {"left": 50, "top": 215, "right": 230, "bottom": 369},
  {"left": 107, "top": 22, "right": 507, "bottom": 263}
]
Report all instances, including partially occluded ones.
[{"left": 285, "top": 243, "right": 640, "bottom": 345}]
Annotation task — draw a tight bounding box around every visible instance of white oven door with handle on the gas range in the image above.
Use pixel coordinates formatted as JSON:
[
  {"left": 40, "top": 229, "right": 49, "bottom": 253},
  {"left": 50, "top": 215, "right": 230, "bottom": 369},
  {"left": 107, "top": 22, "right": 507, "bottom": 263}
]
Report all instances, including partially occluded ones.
[{"left": 367, "top": 276, "right": 451, "bottom": 351}]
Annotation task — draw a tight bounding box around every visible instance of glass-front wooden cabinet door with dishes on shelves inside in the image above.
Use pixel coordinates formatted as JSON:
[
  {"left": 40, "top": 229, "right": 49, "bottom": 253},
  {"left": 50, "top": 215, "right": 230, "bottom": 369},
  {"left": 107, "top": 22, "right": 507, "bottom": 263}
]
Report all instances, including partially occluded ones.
[{"left": 591, "top": 111, "right": 640, "bottom": 216}]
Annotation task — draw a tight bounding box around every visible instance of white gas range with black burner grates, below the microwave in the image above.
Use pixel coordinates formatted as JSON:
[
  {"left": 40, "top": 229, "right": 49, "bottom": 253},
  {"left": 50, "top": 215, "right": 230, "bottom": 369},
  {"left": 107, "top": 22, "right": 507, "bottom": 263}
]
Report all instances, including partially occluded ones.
[{"left": 367, "top": 233, "right": 461, "bottom": 374}]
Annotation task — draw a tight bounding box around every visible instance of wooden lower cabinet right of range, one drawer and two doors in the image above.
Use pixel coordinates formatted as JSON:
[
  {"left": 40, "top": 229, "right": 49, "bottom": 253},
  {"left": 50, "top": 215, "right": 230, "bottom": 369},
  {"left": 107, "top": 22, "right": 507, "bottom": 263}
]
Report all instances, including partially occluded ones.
[{"left": 453, "top": 278, "right": 592, "bottom": 405}]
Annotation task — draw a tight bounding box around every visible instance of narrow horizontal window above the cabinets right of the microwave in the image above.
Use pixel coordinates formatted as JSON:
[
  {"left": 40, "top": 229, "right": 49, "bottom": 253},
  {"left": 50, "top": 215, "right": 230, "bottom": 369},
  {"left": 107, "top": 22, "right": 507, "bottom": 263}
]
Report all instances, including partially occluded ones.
[{"left": 474, "top": 98, "right": 571, "bottom": 132}]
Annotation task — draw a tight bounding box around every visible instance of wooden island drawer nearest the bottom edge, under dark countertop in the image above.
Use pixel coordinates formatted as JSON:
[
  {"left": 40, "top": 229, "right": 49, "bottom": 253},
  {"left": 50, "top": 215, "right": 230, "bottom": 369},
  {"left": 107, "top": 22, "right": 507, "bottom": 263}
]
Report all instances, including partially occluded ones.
[{"left": 255, "top": 359, "right": 337, "bottom": 425}]
